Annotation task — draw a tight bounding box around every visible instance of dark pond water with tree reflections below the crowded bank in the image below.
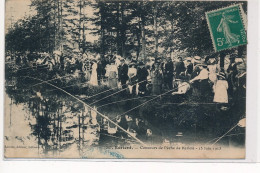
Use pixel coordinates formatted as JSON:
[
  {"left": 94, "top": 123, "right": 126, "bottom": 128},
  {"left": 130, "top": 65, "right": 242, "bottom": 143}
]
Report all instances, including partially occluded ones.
[{"left": 5, "top": 63, "right": 245, "bottom": 157}]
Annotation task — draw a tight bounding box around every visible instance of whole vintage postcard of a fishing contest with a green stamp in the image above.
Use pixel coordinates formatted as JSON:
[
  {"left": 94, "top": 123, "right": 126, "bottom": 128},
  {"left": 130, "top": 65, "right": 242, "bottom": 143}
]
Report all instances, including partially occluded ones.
[{"left": 3, "top": 0, "right": 248, "bottom": 159}]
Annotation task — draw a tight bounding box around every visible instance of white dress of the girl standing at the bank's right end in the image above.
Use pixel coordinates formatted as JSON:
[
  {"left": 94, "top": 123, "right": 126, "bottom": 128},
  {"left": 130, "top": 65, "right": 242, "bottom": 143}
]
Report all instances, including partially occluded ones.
[{"left": 213, "top": 80, "right": 228, "bottom": 103}]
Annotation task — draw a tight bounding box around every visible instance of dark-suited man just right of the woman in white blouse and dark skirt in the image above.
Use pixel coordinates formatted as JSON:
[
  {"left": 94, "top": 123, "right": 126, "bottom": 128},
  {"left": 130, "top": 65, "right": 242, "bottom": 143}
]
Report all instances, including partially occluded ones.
[{"left": 137, "top": 62, "right": 148, "bottom": 95}]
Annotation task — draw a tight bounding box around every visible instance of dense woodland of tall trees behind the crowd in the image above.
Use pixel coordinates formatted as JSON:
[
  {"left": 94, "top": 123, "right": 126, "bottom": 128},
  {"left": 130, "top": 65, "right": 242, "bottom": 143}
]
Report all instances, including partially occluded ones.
[{"left": 6, "top": 0, "right": 246, "bottom": 59}]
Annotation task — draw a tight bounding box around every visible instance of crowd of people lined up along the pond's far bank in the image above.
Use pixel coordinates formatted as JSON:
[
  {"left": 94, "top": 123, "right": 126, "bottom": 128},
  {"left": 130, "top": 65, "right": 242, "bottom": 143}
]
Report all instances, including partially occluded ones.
[{"left": 5, "top": 51, "right": 245, "bottom": 103}]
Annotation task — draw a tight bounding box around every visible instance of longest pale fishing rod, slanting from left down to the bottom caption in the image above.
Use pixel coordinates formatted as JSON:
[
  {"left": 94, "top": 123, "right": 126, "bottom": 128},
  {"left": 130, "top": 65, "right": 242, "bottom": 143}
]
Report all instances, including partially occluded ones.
[{"left": 21, "top": 76, "right": 146, "bottom": 146}]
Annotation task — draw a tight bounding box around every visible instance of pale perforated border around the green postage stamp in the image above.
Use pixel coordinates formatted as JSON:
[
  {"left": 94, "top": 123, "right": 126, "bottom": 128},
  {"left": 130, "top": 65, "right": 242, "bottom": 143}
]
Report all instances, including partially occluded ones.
[{"left": 205, "top": 3, "right": 248, "bottom": 52}]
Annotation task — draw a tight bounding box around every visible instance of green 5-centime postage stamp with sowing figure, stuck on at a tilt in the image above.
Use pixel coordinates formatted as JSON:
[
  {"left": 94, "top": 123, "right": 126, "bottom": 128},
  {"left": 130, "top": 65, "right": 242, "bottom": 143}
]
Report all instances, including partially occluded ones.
[{"left": 206, "top": 4, "right": 247, "bottom": 52}]
